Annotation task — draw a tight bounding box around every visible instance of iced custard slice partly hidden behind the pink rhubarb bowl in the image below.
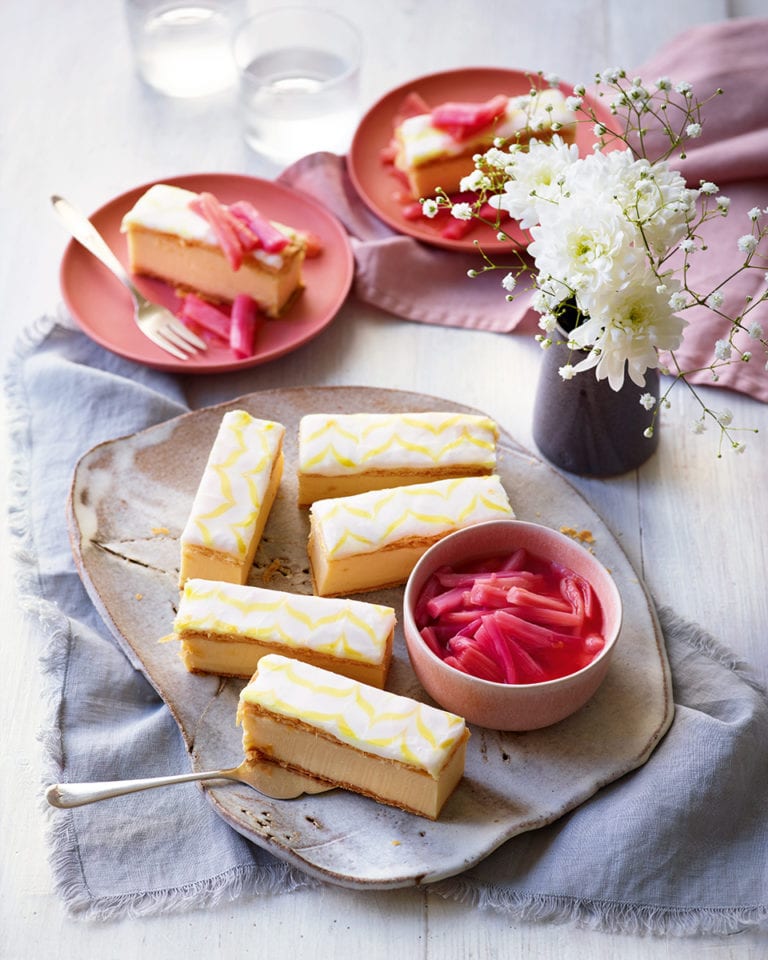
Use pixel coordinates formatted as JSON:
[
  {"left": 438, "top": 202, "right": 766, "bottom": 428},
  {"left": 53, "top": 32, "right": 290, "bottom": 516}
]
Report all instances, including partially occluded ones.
[{"left": 308, "top": 474, "right": 514, "bottom": 596}]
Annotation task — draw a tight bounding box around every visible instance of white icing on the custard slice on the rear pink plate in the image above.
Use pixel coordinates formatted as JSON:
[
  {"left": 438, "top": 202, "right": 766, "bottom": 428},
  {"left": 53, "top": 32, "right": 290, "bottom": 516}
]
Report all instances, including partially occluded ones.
[{"left": 398, "top": 88, "right": 576, "bottom": 167}]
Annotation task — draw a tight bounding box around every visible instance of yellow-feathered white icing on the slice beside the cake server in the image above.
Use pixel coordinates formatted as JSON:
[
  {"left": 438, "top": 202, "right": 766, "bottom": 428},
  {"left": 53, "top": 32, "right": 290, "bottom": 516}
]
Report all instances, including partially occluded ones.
[{"left": 240, "top": 654, "right": 466, "bottom": 778}]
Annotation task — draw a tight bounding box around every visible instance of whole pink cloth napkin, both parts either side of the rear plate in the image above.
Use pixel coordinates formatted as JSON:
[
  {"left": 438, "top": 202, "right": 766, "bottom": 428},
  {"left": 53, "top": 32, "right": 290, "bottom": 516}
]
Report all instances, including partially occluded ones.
[{"left": 278, "top": 18, "right": 768, "bottom": 402}]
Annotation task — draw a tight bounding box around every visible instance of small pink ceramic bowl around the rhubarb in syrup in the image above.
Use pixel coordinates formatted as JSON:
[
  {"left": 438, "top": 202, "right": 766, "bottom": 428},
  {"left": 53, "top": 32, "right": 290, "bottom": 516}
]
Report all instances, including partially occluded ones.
[{"left": 403, "top": 520, "right": 622, "bottom": 730}]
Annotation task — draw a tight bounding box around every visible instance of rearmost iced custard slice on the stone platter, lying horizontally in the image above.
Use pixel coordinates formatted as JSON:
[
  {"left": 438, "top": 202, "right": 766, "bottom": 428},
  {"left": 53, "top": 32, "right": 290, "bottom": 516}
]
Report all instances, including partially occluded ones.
[{"left": 298, "top": 412, "right": 499, "bottom": 506}]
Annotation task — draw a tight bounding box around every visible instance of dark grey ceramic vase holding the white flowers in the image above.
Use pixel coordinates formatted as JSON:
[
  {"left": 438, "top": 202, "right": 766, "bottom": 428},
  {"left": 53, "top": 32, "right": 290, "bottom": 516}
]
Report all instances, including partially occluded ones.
[{"left": 533, "top": 334, "right": 659, "bottom": 477}]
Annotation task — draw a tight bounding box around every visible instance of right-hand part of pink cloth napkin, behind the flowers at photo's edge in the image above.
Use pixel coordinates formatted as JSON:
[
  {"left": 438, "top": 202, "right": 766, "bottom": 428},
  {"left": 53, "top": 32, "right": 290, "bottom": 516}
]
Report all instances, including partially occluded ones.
[{"left": 637, "top": 18, "right": 768, "bottom": 403}]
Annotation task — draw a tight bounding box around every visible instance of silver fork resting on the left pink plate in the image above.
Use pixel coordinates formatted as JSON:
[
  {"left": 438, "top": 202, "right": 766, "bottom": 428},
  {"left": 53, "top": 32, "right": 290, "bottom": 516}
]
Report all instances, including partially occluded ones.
[{"left": 51, "top": 194, "right": 208, "bottom": 360}]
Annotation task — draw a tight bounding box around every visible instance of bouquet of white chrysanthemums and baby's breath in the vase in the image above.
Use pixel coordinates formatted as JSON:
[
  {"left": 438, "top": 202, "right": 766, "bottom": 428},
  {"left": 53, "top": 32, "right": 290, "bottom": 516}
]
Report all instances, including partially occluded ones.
[{"left": 422, "top": 70, "right": 768, "bottom": 451}]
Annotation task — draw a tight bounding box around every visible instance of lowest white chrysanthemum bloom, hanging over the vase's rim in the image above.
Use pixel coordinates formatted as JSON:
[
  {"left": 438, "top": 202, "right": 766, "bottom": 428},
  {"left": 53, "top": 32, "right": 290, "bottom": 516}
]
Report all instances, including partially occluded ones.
[{"left": 571, "top": 273, "right": 687, "bottom": 390}]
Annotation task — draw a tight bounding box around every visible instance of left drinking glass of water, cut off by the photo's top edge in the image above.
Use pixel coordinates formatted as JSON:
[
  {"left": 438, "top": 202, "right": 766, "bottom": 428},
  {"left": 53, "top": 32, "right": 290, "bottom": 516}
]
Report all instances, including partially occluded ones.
[{"left": 125, "top": 0, "right": 244, "bottom": 97}]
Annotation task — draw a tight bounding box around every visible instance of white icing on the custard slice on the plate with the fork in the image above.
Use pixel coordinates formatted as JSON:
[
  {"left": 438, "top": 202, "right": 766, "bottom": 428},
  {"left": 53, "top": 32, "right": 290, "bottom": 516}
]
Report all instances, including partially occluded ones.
[{"left": 121, "top": 183, "right": 292, "bottom": 270}]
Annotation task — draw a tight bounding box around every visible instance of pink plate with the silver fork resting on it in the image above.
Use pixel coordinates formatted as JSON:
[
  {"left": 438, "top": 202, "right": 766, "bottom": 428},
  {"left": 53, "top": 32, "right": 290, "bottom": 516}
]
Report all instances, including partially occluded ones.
[{"left": 61, "top": 173, "right": 354, "bottom": 373}]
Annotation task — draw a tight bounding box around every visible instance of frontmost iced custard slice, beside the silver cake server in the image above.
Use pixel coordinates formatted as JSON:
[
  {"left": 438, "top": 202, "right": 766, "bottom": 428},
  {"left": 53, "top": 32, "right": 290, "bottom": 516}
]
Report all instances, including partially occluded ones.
[{"left": 237, "top": 654, "right": 469, "bottom": 820}]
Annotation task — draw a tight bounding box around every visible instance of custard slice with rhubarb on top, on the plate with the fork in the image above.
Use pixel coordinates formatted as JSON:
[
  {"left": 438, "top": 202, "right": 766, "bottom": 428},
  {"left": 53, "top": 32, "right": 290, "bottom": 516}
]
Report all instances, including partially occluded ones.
[{"left": 122, "top": 183, "right": 306, "bottom": 317}]
